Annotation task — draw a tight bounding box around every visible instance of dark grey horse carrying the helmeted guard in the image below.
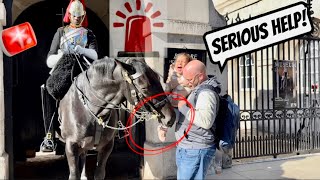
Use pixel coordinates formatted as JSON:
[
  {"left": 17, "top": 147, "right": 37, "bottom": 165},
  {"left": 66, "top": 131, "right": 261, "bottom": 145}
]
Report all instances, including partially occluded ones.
[{"left": 58, "top": 57, "right": 175, "bottom": 179}]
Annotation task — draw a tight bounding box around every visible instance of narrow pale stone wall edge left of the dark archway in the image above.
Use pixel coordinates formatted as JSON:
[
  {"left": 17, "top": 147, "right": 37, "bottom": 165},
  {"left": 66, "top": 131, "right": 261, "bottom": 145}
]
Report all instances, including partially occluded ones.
[{"left": 0, "top": 0, "right": 9, "bottom": 179}]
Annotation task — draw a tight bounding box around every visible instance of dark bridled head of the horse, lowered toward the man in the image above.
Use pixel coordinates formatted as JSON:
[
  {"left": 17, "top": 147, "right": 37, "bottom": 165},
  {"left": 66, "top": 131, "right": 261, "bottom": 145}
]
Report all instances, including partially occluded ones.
[{"left": 117, "top": 59, "right": 175, "bottom": 127}]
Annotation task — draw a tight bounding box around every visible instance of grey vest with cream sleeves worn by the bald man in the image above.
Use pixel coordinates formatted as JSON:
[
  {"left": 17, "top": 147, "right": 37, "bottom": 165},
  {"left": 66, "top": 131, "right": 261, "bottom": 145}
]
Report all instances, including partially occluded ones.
[{"left": 175, "top": 77, "right": 220, "bottom": 149}]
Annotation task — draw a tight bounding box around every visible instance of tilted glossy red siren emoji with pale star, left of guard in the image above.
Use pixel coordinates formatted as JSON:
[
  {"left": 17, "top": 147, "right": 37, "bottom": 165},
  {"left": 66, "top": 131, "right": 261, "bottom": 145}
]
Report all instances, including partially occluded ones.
[{"left": 0, "top": 22, "right": 37, "bottom": 57}]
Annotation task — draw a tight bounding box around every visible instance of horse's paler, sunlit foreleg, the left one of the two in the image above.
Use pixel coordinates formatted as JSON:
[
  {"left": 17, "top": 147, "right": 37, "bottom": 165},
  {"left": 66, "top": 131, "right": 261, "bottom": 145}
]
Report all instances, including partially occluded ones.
[{"left": 65, "top": 141, "right": 80, "bottom": 180}]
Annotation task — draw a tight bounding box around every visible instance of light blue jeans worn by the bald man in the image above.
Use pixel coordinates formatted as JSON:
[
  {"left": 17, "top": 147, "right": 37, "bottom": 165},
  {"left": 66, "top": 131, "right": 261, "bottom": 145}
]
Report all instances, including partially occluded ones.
[{"left": 176, "top": 146, "right": 216, "bottom": 180}]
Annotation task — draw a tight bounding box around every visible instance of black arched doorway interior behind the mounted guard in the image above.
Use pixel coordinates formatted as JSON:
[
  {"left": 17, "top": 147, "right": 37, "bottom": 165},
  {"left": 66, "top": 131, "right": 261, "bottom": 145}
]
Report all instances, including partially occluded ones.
[{"left": 12, "top": 0, "right": 109, "bottom": 160}]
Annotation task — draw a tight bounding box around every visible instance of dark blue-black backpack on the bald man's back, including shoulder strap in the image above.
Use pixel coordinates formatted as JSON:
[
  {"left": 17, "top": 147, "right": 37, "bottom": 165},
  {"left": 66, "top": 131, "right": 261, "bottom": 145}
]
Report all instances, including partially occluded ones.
[{"left": 195, "top": 84, "right": 240, "bottom": 149}]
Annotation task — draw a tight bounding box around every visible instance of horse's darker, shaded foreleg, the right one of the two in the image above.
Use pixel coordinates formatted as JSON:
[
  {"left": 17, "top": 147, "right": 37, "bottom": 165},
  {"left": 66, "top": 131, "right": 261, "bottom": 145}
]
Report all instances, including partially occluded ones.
[{"left": 94, "top": 139, "right": 114, "bottom": 180}]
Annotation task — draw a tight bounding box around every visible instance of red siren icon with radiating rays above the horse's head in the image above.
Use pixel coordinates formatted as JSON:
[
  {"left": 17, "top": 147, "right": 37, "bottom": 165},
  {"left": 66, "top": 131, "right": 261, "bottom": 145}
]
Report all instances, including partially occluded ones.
[{"left": 113, "top": 0, "right": 164, "bottom": 52}]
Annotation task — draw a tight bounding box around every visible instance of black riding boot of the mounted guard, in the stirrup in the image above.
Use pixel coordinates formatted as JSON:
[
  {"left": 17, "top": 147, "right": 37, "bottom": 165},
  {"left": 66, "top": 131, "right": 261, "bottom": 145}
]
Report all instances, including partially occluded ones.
[{"left": 40, "top": 85, "right": 56, "bottom": 152}]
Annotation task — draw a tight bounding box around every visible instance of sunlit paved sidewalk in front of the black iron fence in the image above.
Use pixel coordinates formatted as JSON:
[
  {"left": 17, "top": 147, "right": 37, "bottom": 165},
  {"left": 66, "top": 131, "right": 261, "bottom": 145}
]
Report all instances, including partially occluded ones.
[{"left": 207, "top": 153, "right": 320, "bottom": 179}]
